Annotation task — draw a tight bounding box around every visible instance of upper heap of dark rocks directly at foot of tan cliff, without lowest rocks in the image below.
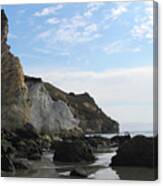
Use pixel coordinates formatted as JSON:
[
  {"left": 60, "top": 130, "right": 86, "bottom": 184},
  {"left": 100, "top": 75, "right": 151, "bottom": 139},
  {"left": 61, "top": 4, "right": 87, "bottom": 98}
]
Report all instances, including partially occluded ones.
[{"left": 2, "top": 124, "right": 42, "bottom": 163}]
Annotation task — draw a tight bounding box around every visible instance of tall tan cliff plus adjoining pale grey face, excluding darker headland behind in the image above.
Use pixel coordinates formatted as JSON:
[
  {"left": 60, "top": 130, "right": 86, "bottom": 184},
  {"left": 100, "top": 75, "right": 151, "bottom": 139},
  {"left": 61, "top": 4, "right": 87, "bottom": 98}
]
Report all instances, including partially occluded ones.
[{"left": 1, "top": 10, "right": 81, "bottom": 133}]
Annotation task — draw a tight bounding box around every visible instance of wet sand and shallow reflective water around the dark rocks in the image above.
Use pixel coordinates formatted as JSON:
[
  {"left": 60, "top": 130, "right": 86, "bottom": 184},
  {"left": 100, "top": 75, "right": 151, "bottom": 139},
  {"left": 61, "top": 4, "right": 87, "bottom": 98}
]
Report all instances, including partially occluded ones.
[{"left": 2, "top": 134, "right": 157, "bottom": 179}]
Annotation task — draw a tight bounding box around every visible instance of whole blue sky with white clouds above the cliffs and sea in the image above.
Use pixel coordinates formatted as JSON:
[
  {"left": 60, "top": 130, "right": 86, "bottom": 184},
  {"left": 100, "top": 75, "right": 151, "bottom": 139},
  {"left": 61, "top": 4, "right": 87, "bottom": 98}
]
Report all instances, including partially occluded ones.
[{"left": 2, "top": 1, "right": 153, "bottom": 129}]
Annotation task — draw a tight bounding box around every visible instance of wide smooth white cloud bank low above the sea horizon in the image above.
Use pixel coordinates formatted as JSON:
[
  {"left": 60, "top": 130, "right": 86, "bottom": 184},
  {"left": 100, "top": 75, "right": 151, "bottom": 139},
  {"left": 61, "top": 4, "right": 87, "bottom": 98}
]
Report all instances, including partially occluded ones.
[{"left": 26, "top": 66, "right": 153, "bottom": 123}]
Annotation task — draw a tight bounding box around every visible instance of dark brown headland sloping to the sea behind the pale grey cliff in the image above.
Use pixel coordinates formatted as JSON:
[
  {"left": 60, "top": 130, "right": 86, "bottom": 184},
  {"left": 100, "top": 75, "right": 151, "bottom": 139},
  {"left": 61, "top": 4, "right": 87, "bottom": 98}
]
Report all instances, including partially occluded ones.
[{"left": 45, "top": 83, "right": 119, "bottom": 133}]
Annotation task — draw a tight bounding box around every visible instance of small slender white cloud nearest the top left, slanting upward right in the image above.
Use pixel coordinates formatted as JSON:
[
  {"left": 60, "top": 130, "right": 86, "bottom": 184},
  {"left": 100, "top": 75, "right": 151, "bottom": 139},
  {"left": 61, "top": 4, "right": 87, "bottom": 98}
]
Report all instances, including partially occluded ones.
[{"left": 33, "top": 4, "right": 63, "bottom": 17}]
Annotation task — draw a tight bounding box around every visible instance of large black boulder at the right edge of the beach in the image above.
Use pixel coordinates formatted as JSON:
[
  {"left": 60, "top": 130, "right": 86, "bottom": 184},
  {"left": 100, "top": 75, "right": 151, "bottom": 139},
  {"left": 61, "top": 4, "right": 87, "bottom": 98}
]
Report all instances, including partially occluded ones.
[{"left": 111, "top": 136, "right": 157, "bottom": 168}]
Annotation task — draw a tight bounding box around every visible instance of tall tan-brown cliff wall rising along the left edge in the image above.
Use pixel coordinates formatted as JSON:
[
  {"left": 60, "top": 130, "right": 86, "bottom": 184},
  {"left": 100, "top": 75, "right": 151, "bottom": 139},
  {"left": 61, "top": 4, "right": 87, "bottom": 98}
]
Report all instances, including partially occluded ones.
[{"left": 1, "top": 10, "right": 30, "bottom": 128}]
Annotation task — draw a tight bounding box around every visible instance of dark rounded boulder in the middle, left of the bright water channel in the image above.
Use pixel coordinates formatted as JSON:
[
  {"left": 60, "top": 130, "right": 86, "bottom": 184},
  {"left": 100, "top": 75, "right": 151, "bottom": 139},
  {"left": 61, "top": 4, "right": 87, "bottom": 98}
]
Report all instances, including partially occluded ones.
[{"left": 53, "top": 139, "right": 95, "bottom": 162}]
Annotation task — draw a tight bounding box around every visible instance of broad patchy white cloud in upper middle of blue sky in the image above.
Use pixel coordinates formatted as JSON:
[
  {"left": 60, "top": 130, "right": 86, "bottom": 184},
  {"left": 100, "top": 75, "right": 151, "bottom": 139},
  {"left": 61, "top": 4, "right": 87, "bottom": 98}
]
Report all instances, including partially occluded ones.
[{"left": 38, "top": 15, "right": 101, "bottom": 44}]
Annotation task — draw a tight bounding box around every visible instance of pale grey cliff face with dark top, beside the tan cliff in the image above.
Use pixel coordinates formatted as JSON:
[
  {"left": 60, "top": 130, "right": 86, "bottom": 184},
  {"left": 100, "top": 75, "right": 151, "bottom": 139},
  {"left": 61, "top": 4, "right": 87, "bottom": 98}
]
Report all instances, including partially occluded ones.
[{"left": 25, "top": 76, "right": 78, "bottom": 134}]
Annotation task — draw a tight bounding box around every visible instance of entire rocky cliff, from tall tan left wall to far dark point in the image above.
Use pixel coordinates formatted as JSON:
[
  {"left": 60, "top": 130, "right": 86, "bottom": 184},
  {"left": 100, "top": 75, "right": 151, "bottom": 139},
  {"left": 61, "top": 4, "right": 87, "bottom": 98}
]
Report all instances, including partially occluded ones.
[{"left": 1, "top": 10, "right": 118, "bottom": 134}]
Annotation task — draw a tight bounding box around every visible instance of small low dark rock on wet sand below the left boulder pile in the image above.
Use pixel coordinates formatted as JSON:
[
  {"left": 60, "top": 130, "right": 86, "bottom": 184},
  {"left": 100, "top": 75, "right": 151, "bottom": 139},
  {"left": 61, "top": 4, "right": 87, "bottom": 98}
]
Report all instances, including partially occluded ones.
[{"left": 13, "top": 158, "right": 31, "bottom": 169}]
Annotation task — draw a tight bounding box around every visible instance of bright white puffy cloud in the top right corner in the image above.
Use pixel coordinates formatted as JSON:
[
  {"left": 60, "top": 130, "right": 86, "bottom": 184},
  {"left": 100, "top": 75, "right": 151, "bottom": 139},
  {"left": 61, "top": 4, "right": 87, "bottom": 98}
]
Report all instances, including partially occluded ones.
[{"left": 131, "top": 1, "right": 153, "bottom": 41}]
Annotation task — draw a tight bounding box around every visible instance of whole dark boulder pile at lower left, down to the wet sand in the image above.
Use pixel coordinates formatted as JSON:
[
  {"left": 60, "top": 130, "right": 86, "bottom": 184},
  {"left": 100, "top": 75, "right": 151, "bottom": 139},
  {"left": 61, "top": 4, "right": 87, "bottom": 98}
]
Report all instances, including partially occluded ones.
[{"left": 1, "top": 123, "right": 42, "bottom": 172}]
